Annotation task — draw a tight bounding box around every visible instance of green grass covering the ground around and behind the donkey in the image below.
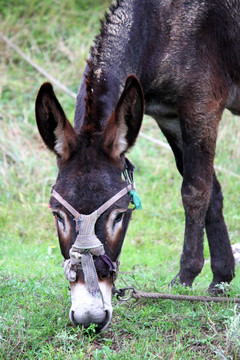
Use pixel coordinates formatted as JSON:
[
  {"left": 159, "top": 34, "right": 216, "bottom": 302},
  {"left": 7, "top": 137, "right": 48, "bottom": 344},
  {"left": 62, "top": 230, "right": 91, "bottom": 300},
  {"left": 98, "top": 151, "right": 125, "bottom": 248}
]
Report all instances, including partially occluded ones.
[{"left": 0, "top": 0, "right": 240, "bottom": 360}]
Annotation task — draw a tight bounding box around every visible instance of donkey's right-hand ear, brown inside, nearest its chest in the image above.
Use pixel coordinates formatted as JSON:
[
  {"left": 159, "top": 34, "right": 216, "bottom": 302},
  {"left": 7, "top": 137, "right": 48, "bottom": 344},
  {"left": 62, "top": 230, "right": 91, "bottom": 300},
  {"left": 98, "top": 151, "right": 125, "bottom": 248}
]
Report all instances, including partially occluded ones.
[{"left": 104, "top": 75, "right": 144, "bottom": 158}]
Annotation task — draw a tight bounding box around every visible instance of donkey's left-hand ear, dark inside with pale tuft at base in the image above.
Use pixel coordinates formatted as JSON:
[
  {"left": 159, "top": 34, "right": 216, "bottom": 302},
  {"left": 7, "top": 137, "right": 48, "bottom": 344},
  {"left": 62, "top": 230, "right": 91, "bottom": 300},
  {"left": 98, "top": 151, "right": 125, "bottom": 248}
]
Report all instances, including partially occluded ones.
[{"left": 35, "top": 83, "right": 77, "bottom": 160}]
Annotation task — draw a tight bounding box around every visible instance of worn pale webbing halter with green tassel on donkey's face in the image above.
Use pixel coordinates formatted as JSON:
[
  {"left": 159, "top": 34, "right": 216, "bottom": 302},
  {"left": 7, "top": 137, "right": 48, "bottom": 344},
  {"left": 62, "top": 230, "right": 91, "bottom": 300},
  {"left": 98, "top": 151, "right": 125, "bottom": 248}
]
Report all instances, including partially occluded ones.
[{"left": 51, "top": 158, "right": 141, "bottom": 297}]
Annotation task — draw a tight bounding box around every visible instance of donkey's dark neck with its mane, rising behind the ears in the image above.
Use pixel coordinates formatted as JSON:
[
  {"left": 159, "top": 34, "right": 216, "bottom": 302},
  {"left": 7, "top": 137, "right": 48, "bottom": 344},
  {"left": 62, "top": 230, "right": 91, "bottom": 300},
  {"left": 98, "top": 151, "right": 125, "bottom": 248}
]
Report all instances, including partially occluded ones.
[{"left": 74, "top": 0, "right": 156, "bottom": 132}]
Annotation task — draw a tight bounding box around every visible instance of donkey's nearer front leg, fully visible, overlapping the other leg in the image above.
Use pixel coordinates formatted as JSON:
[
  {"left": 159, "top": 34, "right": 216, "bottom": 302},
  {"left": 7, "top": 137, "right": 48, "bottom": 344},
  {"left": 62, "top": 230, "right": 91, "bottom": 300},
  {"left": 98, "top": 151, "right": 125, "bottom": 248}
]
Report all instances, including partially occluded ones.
[{"left": 178, "top": 104, "right": 220, "bottom": 286}]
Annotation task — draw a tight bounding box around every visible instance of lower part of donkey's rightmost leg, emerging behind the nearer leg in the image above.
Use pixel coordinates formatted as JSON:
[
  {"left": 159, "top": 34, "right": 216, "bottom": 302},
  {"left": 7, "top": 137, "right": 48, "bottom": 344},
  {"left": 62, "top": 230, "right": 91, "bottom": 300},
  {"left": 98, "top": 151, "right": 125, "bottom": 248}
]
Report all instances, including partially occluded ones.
[{"left": 205, "top": 173, "right": 234, "bottom": 293}]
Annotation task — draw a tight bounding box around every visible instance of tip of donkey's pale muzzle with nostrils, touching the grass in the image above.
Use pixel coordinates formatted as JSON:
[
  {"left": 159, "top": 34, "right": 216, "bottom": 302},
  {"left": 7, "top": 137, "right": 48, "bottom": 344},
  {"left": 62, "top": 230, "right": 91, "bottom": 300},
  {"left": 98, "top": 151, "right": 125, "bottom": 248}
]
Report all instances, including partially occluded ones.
[{"left": 69, "top": 309, "right": 111, "bottom": 331}]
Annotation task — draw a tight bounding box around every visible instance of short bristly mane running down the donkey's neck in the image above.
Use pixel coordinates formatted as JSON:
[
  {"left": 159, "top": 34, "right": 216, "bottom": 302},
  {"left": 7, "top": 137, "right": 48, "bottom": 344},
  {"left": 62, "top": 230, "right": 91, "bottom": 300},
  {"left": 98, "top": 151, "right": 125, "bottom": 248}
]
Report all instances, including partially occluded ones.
[{"left": 82, "top": 0, "right": 134, "bottom": 138}]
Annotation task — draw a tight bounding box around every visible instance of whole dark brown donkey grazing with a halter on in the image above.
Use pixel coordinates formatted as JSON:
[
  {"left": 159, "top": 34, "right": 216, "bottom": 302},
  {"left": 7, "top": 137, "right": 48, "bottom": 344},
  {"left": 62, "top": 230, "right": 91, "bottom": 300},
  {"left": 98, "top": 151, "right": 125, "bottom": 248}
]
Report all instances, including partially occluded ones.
[{"left": 36, "top": 0, "right": 240, "bottom": 331}]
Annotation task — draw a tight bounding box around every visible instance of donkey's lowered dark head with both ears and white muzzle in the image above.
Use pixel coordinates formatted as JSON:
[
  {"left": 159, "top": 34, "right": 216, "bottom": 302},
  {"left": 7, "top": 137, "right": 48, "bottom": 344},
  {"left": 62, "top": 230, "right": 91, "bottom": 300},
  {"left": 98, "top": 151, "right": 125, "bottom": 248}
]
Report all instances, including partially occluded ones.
[{"left": 36, "top": 76, "right": 144, "bottom": 331}]
